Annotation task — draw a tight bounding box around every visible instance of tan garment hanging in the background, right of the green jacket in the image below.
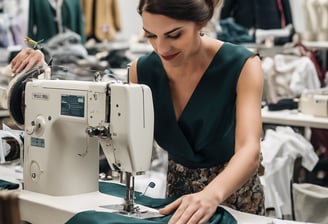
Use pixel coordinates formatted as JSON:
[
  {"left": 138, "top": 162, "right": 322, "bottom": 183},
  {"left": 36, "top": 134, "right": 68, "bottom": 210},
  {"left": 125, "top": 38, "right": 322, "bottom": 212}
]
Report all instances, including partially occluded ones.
[{"left": 81, "top": 0, "right": 121, "bottom": 41}]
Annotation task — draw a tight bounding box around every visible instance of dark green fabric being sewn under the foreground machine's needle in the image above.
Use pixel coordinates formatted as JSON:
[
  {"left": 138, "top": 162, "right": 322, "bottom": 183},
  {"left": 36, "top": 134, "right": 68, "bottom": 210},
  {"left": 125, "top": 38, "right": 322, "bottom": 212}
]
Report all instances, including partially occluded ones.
[{"left": 66, "top": 182, "right": 237, "bottom": 224}]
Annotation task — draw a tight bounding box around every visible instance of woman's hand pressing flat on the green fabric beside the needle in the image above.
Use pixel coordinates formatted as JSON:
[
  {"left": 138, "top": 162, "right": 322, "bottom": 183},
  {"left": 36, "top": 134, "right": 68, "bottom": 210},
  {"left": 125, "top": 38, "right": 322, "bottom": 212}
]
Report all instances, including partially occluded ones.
[{"left": 159, "top": 190, "right": 218, "bottom": 224}]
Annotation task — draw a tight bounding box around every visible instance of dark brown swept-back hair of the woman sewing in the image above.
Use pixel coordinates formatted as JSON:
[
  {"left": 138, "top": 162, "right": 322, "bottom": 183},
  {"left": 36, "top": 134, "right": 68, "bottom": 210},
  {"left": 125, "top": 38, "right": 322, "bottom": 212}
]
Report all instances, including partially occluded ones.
[{"left": 138, "top": 0, "right": 223, "bottom": 23}]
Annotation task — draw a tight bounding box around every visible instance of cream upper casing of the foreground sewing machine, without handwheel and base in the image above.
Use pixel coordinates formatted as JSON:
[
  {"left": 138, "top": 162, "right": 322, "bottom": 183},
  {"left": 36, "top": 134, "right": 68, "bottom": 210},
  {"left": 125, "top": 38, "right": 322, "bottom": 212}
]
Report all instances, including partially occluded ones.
[{"left": 23, "top": 80, "right": 153, "bottom": 196}]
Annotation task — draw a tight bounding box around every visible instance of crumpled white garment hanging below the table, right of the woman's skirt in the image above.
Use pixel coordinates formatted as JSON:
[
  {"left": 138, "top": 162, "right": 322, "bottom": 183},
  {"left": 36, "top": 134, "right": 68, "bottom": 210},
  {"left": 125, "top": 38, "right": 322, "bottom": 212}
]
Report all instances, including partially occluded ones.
[{"left": 261, "top": 127, "right": 319, "bottom": 218}]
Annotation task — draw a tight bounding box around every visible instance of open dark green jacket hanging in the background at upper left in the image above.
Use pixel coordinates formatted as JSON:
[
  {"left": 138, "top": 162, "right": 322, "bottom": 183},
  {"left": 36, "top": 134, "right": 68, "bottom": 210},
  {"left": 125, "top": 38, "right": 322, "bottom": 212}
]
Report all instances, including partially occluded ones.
[{"left": 28, "top": 0, "right": 85, "bottom": 43}]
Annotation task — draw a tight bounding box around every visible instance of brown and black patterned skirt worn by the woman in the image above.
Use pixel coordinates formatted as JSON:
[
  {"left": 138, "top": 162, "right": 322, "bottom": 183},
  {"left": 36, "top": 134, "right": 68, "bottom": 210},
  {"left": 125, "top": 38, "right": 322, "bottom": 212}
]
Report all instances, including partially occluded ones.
[{"left": 166, "top": 160, "right": 265, "bottom": 215}]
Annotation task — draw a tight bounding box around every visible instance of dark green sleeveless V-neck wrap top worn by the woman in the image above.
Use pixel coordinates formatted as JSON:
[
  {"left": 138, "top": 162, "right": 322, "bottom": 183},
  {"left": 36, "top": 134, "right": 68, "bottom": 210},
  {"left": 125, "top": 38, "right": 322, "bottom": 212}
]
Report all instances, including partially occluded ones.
[{"left": 137, "top": 43, "right": 253, "bottom": 168}]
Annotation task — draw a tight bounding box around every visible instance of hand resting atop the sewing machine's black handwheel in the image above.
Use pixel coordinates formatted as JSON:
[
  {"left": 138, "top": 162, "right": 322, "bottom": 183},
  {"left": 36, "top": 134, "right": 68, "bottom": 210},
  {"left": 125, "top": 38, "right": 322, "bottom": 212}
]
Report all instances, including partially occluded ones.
[{"left": 11, "top": 48, "right": 45, "bottom": 75}]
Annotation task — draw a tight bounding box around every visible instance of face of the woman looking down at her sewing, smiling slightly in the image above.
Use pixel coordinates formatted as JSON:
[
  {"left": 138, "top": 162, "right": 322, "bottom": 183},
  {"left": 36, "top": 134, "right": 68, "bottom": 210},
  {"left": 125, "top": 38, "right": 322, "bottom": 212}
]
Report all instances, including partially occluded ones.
[{"left": 142, "top": 12, "right": 202, "bottom": 66}]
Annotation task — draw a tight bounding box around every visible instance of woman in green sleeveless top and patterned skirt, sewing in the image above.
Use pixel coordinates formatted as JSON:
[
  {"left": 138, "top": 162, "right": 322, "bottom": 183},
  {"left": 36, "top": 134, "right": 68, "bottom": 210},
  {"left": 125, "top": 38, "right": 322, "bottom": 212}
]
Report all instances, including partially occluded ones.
[{"left": 12, "top": 0, "right": 264, "bottom": 224}]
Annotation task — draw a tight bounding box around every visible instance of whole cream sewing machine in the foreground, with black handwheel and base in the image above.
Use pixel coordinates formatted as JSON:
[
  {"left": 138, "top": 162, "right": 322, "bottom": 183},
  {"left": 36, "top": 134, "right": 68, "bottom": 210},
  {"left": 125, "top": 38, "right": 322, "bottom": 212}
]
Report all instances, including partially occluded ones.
[{"left": 8, "top": 69, "right": 158, "bottom": 224}]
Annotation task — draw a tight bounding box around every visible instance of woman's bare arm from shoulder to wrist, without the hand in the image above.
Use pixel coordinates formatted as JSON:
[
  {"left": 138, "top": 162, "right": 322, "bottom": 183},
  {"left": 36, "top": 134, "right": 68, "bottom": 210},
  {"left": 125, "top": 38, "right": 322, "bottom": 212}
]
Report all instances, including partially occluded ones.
[{"left": 204, "top": 54, "right": 263, "bottom": 203}]
